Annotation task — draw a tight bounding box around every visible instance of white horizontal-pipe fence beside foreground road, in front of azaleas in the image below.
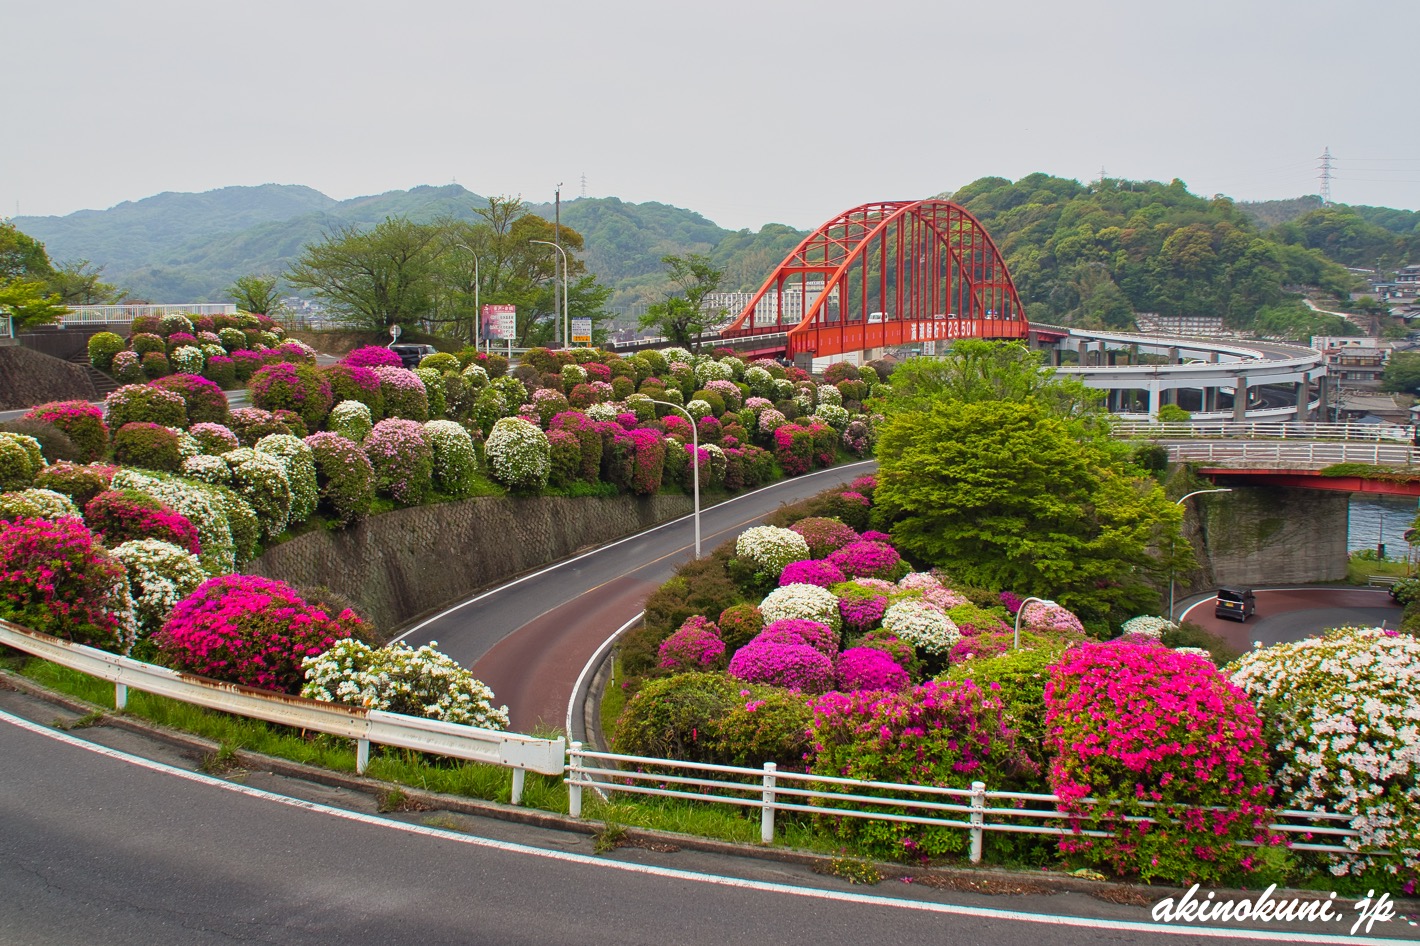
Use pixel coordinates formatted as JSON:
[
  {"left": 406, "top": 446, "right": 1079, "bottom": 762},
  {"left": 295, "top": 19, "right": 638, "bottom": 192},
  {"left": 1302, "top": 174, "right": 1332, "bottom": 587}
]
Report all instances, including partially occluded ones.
[{"left": 567, "top": 743, "right": 1360, "bottom": 864}]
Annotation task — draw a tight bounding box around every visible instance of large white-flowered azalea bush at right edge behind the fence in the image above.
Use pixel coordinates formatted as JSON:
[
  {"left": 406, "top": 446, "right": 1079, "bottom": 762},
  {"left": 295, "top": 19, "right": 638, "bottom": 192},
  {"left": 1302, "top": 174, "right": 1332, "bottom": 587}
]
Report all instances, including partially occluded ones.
[{"left": 1227, "top": 628, "right": 1420, "bottom": 881}]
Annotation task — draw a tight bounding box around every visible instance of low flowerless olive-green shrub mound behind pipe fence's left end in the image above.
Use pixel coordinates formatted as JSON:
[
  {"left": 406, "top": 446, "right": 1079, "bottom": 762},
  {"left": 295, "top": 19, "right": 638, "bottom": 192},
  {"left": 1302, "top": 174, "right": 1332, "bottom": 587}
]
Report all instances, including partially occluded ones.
[{"left": 615, "top": 673, "right": 811, "bottom": 768}]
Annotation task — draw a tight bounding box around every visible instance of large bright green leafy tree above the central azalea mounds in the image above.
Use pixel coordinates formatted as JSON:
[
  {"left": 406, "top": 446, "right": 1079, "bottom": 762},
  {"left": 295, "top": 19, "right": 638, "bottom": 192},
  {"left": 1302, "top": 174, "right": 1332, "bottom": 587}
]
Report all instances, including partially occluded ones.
[{"left": 875, "top": 398, "right": 1187, "bottom": 618}]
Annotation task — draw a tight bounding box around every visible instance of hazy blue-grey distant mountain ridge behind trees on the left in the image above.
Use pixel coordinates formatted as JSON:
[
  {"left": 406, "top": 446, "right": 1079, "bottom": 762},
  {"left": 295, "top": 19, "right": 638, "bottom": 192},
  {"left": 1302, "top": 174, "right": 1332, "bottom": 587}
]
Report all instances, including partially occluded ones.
[{"left": 11, "top": 183, "right": 802, "bottom": 307}]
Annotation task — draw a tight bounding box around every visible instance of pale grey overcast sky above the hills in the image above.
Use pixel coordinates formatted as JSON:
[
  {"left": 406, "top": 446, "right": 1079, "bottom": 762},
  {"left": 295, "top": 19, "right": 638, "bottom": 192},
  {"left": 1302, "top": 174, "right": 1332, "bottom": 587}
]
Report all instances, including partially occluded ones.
[{"left": 0, "top": 0, "right": 1420, "bottom": 229}]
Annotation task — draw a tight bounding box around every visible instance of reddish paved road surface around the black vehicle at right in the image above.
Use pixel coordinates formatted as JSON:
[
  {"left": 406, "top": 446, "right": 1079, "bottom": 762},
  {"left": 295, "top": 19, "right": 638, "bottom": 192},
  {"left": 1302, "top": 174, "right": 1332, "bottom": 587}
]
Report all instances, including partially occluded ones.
[{"left": 1184, "top": 588, "right": 1400, "bottom": 651}]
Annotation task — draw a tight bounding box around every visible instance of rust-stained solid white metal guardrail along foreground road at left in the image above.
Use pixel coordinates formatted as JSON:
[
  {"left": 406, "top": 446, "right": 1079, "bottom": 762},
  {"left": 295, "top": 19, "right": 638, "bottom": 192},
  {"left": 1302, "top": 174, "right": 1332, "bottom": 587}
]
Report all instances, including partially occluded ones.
[{"left": 0, "top": 621, "right": 567, "bottom": 804}]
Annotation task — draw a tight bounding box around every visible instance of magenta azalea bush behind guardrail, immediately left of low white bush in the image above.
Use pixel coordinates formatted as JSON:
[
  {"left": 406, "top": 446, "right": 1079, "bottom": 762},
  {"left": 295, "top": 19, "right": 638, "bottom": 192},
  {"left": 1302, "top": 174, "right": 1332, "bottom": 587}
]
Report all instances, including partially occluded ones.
[{"left": 155, "top": 575, "right": 361, "bottom": 696}]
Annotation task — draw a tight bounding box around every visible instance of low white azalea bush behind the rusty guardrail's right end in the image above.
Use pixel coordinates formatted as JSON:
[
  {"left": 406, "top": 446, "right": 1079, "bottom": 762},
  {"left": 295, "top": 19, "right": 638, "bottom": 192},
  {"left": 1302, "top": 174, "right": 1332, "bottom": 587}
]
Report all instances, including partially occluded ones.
[{"left": 301, "top": 638, "right": 508, "bottom": 730}]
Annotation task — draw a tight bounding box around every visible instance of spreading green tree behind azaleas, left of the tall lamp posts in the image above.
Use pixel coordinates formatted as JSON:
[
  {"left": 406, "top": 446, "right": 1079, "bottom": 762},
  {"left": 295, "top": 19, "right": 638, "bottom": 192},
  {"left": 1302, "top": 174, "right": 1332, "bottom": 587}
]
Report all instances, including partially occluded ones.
[{"left": 287, "top": 217, "right": 442, "bottom": 331}]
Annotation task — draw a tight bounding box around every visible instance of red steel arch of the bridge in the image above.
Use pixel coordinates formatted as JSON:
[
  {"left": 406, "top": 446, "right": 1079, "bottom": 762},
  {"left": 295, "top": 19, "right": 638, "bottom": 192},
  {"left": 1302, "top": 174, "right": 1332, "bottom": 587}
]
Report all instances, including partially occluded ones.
[{"left": 720, "top": 200, "right": 1030, "bottom": 357}]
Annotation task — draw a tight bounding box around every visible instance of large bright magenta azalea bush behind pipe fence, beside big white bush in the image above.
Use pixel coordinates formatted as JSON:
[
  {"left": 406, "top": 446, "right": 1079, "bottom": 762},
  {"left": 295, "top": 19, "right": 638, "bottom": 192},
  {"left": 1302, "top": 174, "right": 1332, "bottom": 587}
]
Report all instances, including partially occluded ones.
[{"left": 1045, "top": 641, "right": 1281, "bottom": 884}]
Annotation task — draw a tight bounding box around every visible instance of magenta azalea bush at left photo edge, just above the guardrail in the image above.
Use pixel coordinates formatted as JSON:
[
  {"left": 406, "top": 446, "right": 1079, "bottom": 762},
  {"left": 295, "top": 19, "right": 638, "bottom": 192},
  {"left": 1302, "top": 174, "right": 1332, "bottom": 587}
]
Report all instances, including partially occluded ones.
[{"left": 0, "top": 518, "right": 135, "bottom": 653}]
